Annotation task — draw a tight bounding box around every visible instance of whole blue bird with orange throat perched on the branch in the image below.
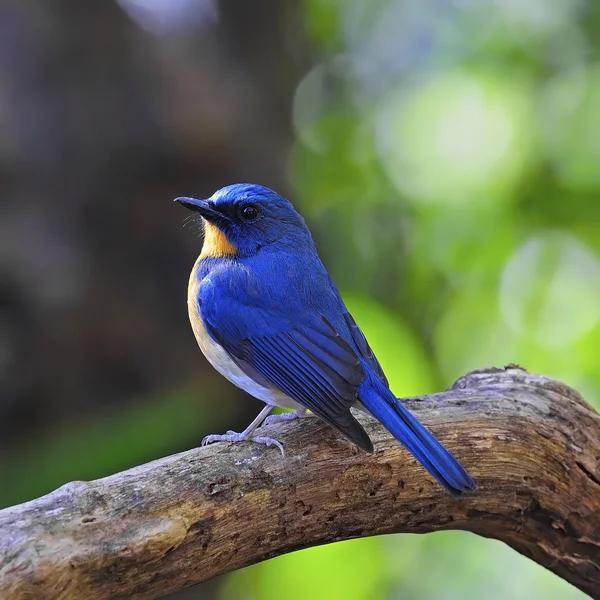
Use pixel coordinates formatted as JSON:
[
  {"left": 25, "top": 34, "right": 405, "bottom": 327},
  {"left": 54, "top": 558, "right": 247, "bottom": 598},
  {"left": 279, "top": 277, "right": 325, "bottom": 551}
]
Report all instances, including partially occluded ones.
[{"left": 175, "top": 184, "right": 475, "bottom": 495}]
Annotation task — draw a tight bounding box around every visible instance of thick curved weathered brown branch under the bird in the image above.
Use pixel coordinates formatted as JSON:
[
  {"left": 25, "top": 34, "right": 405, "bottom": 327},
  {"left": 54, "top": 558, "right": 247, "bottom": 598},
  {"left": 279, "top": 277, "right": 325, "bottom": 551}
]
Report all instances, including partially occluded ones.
[{"left": 0, "top": 366, "right": 600, "bottom": 600}]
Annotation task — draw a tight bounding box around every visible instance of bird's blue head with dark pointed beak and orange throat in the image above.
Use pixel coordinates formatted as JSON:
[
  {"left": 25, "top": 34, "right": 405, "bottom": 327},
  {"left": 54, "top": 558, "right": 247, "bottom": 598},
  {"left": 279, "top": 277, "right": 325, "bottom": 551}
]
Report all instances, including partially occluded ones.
[{"left": 175, "top": 183, "right": 313, "bottom": 258}]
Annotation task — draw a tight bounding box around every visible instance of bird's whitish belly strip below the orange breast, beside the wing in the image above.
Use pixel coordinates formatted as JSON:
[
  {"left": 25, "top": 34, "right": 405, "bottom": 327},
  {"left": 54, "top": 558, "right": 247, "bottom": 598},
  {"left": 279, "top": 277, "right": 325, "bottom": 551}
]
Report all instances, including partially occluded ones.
[{"left": 188, "top": 269, "right": 302, "bottom": 410}]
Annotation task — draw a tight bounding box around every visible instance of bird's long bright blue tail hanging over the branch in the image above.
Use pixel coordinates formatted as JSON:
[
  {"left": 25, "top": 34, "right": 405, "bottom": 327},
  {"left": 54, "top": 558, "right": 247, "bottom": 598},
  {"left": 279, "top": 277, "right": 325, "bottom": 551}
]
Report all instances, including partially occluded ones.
[{"left": 359, "top": 373, "right": 476, "bottom": 496}]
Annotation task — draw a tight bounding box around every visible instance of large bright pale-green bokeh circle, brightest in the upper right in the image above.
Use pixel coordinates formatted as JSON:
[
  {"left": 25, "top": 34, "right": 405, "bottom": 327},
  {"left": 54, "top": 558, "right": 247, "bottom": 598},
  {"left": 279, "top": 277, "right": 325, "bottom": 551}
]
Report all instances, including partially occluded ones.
[{"left": 377, "top": 72, "right": 532, "bottom": 206}]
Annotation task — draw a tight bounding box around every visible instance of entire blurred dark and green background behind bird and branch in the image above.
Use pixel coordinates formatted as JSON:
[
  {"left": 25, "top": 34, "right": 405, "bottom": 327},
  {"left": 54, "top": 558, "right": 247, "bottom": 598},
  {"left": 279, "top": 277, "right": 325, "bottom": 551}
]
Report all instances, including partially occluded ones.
[{"left": 0, "top": 0, "right": 600, "bottom": 600}]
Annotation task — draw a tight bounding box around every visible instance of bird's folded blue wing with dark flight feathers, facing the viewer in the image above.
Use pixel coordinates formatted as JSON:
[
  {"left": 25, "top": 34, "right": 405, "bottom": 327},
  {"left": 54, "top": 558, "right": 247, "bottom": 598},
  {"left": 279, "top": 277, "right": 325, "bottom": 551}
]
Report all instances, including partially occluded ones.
[{"left": 198, "top": 276, "right": 373, "bottom": 452}]
